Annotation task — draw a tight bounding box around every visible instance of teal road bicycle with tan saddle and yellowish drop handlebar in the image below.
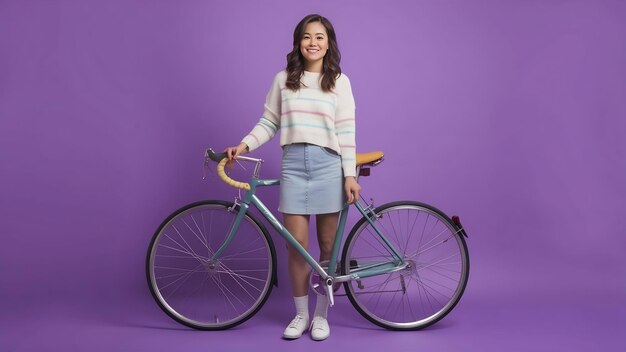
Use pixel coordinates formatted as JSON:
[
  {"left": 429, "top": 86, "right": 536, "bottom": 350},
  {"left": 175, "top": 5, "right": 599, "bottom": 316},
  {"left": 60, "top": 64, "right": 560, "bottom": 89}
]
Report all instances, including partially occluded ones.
[{"left": 146, "top": 148, "right": 469, "bottom": 330}]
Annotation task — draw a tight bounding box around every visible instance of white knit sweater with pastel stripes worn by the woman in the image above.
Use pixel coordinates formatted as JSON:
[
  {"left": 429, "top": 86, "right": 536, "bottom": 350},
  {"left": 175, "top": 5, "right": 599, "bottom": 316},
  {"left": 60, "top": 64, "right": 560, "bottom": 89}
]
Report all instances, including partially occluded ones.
[{"left": 242, "top": 71, "right": 356, "bottom": 176}]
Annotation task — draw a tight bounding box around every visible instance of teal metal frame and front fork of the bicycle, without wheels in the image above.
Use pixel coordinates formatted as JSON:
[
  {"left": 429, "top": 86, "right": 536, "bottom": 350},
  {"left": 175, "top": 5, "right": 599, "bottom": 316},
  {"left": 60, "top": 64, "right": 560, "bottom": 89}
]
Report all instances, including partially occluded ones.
[{"left": 211, "top": 179, "right": 406, "bottom": 304}]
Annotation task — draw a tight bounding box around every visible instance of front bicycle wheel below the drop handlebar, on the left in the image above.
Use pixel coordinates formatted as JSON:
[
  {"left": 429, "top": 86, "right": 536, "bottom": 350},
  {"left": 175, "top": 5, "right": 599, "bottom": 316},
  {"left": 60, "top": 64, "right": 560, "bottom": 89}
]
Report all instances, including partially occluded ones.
[{"left": 146, "top": 201, "right": 276, "bottom": 330}]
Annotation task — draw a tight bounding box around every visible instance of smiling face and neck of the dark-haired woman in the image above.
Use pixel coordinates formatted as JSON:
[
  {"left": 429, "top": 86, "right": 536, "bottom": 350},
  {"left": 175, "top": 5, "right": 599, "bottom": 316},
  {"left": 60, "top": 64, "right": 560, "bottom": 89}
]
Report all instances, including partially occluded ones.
[{"left": 300, "top": 22, "right": 328, "bottom": 72}]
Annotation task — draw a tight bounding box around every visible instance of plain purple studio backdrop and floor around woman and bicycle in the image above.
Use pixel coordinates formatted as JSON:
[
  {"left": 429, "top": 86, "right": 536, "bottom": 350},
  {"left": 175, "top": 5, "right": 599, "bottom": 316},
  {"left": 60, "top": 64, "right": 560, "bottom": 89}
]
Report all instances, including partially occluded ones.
[{"left": 0, "top": 0, "right": 626, "bottom": 351}]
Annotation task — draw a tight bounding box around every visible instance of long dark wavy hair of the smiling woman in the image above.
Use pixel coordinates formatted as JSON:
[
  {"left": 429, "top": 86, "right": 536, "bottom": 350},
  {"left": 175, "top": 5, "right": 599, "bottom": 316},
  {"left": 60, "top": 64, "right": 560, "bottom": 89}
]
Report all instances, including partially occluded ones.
[{"left": 285, "top": 14, "right": 341, "bottom": 92}]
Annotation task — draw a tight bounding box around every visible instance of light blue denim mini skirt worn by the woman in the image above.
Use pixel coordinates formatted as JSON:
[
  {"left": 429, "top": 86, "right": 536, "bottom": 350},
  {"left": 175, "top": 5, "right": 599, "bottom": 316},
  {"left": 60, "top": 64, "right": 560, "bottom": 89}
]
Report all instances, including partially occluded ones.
[{"left": 278, "top": 143, "right": 344, "bottom": 214}]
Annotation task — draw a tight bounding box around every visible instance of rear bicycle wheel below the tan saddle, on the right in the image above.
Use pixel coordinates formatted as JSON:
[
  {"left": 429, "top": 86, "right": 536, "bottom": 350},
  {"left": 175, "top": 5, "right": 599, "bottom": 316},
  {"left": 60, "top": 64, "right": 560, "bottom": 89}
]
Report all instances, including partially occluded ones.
[{"left": 342, "top": 201, "right": 469, "bottom": 330}]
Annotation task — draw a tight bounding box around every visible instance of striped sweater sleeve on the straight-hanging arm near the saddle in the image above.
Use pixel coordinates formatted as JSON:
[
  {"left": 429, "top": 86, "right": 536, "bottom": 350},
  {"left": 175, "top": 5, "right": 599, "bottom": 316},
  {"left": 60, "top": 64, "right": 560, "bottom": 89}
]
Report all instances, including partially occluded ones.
[{"left": 335, "top": 74, "right": 356, "bottom": 176}]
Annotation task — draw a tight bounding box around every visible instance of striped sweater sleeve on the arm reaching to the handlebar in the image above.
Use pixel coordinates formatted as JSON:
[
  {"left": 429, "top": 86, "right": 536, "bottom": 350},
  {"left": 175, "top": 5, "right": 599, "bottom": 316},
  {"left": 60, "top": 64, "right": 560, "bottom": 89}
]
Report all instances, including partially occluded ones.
[{"left": 241, "top": 72, "right": 282, "bottom": 151}]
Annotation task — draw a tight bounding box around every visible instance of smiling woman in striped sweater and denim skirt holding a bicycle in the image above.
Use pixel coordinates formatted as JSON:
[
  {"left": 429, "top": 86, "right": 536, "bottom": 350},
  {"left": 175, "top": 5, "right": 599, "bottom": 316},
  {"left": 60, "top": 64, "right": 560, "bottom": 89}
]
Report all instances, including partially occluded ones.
[{"left": 226, "top": 14, "right": 360, "bottom": 341}]
